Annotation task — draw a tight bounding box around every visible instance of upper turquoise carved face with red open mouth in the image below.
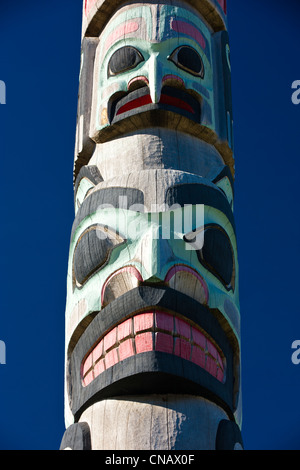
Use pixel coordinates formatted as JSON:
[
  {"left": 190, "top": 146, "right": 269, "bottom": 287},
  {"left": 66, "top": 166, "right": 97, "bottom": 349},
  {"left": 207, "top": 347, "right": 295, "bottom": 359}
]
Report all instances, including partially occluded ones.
[{"left": 92, "top": 4, "right": 215, "bottom": 141}]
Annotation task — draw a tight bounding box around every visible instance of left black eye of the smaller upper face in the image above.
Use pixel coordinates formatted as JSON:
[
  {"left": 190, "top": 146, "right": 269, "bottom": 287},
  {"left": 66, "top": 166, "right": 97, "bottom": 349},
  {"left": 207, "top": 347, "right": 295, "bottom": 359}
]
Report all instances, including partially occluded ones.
[{"left": 107, "top": 46, "right": 144, "bottom": 77}]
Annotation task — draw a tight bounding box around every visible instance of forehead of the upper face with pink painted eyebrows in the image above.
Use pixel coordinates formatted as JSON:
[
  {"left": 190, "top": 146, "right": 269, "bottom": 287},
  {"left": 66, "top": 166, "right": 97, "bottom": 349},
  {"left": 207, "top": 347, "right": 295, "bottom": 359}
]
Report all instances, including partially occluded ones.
[{"left": 100, "top": 3, "right": 210, "bottom": 54}]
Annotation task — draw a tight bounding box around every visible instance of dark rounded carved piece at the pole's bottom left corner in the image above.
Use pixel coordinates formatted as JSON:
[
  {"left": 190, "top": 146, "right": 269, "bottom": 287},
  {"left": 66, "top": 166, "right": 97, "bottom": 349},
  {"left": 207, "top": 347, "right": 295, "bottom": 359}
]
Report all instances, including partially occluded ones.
[{"left": 59, "top": 423, "right": 92, "bottom": 450}]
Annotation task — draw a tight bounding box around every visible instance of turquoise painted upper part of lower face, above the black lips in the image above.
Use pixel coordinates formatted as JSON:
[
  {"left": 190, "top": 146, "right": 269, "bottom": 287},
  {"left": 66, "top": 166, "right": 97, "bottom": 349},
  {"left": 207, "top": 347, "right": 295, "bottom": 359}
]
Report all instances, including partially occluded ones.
[{"left": 67, "top": 198, "right": 240, "bottom": 356}]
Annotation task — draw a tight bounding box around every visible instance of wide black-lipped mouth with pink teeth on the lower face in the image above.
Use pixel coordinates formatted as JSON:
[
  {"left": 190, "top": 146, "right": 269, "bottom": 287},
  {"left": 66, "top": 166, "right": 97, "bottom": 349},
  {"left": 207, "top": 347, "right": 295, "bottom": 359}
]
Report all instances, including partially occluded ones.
[{"left": 67, "top": 284, "right": 239, "bottom": 419}]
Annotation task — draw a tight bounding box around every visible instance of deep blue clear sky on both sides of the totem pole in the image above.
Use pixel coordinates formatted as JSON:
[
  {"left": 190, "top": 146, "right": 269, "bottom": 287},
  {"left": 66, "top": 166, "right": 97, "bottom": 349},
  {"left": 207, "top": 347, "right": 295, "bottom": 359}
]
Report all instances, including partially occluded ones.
[{"left": 0, "top": 0, "right": 300, "bottom": 450}]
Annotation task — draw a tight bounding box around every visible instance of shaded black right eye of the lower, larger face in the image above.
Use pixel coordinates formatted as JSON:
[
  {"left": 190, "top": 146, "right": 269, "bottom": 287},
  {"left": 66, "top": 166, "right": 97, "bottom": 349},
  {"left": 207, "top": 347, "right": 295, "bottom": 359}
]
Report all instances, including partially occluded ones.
[{"left": 184, "top": 225, "right": 235, "bottom": 289}]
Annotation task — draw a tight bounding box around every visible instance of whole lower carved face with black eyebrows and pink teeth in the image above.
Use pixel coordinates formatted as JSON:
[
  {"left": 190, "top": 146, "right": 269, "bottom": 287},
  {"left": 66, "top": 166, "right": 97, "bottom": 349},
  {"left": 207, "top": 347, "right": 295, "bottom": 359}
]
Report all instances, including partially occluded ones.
[{"left": 67, "top": 179, "right": 239, "bottom": 422}]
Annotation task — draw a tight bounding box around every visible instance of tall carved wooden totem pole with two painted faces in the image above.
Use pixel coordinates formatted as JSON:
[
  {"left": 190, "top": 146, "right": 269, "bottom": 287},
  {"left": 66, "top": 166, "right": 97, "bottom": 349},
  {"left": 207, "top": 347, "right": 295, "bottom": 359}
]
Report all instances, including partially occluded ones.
[{"left": 61, "top": 0, "right": 243, "bottom": 450}]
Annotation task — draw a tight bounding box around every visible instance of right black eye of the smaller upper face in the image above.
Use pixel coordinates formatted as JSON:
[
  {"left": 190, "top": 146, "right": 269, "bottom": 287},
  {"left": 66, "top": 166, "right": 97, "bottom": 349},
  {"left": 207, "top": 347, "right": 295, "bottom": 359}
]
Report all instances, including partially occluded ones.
[{"left": 168, "top": 46, "right": 204, "bottom": 78}]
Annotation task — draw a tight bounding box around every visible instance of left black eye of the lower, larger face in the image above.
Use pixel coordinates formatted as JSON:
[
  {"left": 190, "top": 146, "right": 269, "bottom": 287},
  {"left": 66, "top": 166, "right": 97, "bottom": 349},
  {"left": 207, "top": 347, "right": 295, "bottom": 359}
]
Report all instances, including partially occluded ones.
[{"left": 73, "top": 225, "right": 125, "bottom": 285}]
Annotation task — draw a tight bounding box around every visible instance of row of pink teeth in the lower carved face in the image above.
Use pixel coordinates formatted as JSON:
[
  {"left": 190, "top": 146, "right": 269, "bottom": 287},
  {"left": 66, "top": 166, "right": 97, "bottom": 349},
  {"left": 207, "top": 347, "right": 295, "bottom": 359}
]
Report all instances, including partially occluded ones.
[{"left": 81, "top": 311, "right": 225, "bottom": 387}]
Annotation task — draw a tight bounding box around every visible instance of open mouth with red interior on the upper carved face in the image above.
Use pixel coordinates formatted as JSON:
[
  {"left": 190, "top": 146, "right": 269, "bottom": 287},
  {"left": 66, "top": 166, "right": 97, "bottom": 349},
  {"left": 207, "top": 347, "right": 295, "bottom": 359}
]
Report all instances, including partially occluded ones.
[{"left": 108, "top": 86, "right": 200, "bottom": 124}]
